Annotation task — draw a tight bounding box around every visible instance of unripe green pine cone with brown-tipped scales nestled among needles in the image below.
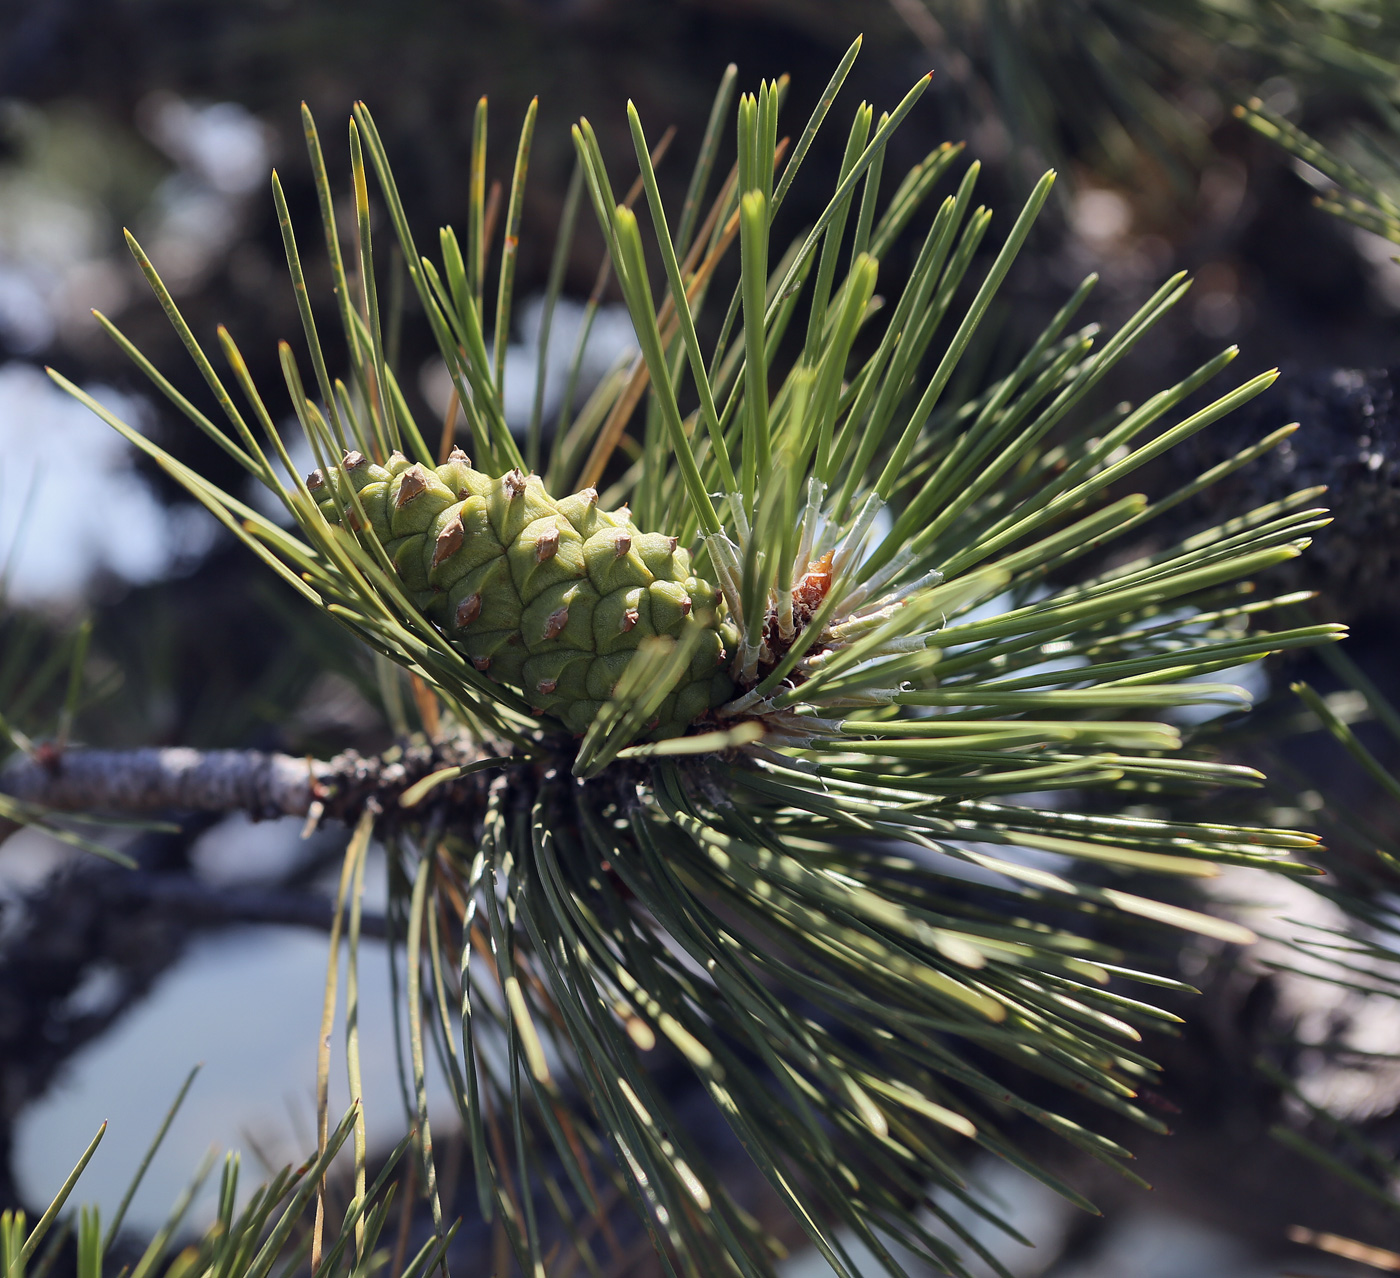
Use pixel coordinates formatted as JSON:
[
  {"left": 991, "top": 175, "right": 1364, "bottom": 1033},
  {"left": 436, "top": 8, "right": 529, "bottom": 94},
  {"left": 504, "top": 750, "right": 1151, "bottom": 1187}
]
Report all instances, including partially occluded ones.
[{"left": 307, "top": 448, "right": 734, "bottom": 739}]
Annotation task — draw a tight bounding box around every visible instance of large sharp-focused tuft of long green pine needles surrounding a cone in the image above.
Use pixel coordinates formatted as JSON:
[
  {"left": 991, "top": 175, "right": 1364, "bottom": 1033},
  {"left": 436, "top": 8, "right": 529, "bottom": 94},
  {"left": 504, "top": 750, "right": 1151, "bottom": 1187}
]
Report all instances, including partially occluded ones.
[{"left": 46, "top": 46, "right": 1337, "bottom": 1275}]
